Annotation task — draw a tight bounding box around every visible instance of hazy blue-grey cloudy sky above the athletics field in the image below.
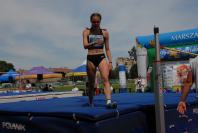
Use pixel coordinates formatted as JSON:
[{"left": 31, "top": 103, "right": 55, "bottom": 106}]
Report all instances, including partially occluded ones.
[{"left": 0, "top": 0, "right": 198, "bottom": 69}]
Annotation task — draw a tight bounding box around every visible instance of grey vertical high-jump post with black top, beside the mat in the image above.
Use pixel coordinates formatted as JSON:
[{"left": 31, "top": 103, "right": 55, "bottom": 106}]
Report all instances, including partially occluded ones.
[{"left": 154, "top": 27, "right": 165, "bottom": 133}]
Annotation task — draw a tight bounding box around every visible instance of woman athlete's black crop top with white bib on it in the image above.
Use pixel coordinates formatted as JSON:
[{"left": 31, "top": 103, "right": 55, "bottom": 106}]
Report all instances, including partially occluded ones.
[{"left": 88, "top": 29, "right": 105, "bottom": 49}]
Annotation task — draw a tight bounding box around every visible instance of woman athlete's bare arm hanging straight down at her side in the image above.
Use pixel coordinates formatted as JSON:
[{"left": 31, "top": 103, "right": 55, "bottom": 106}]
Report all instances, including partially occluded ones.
[{"left": 104, "top": 30, "right": 112, "bottom": 69}]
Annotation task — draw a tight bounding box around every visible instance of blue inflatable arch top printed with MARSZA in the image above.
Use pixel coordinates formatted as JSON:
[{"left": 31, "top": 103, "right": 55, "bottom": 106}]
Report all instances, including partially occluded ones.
[{"left": 136, "top": 28, "right": 198, "bottom": 48}]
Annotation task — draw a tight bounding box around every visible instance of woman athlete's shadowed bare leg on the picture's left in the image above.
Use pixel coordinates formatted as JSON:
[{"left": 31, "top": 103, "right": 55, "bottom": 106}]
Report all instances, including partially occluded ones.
[{"left": 87, "top": 60, "right": 96, "bottom": 105}]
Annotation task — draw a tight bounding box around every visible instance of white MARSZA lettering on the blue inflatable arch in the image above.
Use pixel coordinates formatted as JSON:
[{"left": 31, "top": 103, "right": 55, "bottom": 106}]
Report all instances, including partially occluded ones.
[{"left": 171, "top": 32, "right": 198, "bottom": 41}]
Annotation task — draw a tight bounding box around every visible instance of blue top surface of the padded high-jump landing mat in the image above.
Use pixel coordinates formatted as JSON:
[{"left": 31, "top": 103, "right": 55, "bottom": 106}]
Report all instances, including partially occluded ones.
[{"left": 0, "top": 93, "right": 196, "bottom": 121}]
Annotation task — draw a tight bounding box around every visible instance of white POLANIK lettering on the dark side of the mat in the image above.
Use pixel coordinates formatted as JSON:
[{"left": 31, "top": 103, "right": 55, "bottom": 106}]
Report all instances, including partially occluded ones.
[{"left": 1, "top": 122, "right": 26, "bottom": 131}]
